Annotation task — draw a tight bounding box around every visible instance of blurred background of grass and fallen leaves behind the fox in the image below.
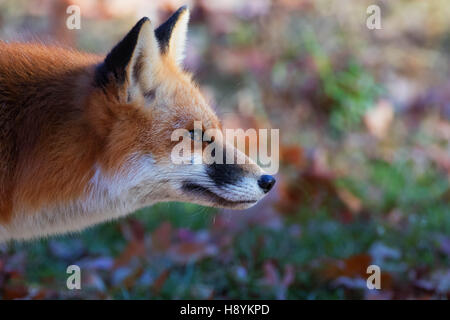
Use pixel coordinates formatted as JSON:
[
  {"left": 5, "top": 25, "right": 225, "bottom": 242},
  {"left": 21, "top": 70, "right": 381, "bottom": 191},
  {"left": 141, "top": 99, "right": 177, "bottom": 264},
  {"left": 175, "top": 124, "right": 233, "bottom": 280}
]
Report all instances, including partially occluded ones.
[{"left": 0, "top": 0, "right": 450, "bottom": 299}]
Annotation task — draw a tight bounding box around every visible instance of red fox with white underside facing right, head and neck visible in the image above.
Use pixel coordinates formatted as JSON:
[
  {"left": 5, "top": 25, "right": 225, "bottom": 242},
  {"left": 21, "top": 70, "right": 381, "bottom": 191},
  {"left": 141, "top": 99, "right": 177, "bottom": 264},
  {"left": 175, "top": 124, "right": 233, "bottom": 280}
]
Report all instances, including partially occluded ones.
[{"left": 0, "top": 7, "right": 275, "bottom": 241}]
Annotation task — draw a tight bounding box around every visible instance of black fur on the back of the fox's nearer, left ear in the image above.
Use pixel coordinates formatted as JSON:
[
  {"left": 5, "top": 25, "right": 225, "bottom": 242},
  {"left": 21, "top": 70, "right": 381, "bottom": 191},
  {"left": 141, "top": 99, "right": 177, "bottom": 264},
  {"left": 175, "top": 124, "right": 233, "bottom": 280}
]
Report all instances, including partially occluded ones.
[{"left": 95, "top": 17, "right": 149, "bottom": 87}]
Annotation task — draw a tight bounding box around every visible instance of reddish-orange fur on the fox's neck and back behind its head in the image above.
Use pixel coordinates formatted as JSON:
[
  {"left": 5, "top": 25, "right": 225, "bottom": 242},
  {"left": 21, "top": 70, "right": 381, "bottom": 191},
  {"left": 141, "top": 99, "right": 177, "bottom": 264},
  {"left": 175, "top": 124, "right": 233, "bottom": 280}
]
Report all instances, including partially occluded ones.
[{"left": 0, "top": 42, "right": 102, "bottom": 222}]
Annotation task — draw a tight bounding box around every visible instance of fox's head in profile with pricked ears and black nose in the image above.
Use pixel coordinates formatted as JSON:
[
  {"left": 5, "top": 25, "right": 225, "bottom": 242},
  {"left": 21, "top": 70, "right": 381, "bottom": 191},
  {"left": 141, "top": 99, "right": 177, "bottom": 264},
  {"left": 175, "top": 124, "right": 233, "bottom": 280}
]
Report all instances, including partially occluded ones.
[{"left": 88, "top": 7, "right": 275, "bottom": 209}]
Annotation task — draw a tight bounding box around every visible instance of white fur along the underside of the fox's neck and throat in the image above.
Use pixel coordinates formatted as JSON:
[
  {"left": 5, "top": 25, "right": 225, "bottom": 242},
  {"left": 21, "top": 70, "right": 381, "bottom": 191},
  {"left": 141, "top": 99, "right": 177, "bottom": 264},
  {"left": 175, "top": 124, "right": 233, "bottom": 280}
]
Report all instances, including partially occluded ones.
[{"left": 0, "top": 157, "right": 166, "bottom": 242}]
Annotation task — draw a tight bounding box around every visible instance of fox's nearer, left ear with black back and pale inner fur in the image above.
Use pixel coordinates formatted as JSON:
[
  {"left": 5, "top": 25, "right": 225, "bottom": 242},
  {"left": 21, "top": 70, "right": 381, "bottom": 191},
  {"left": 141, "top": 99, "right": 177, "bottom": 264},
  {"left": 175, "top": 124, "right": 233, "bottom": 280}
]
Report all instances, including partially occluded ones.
[{"left": 95, "top": 17, "right": 160, "bottom": 100}]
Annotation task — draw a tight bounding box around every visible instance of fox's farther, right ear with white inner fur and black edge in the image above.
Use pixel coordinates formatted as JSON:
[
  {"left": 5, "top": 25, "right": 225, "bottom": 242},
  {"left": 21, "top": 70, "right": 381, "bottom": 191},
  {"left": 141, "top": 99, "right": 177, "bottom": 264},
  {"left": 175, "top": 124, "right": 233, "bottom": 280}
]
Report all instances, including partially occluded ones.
[{"left": 155, "top": 6, "right": 189, "bottom": 65}]
